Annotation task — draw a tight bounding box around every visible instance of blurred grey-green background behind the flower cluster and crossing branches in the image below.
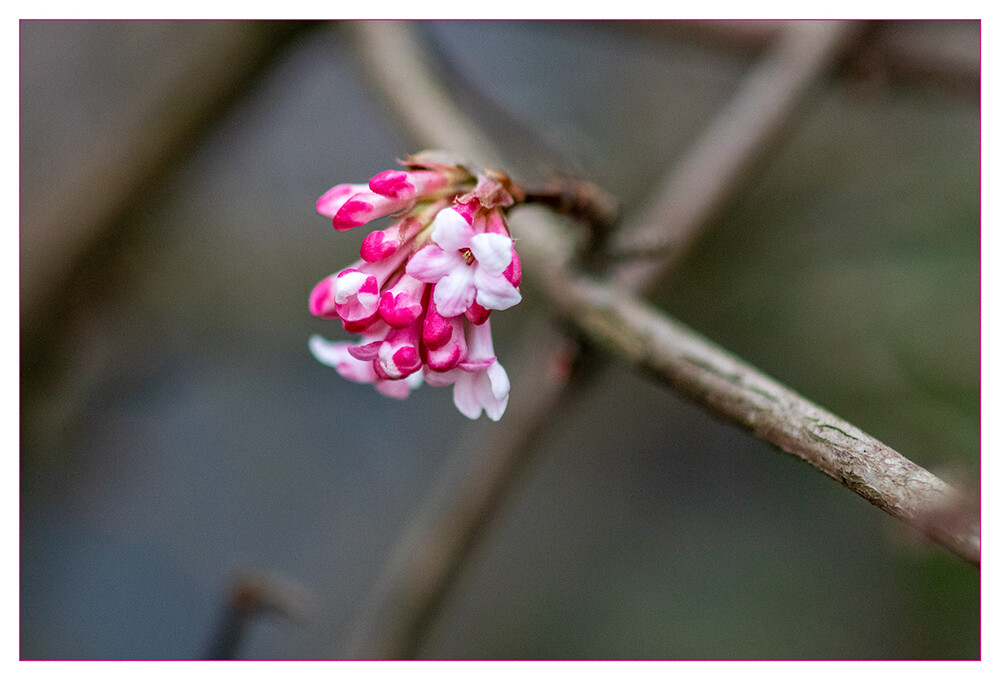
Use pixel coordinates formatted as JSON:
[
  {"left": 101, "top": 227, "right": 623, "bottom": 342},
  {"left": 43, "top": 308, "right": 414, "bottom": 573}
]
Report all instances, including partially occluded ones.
[{"left": 20, "top": 21, "right": 980, "bottom": 659}]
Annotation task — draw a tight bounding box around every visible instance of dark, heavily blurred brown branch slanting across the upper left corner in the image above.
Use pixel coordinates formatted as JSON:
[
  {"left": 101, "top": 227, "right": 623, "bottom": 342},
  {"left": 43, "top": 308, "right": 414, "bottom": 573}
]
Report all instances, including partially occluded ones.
[{"left": 21, "top": 22, "right": 302, "bottom": 354}]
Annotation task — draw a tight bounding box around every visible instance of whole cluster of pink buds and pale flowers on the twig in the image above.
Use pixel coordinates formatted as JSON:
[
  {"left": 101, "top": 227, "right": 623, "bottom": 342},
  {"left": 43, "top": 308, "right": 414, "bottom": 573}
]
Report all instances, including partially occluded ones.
[{"left": 309, "top": 153, "right": 521, "bottom": 420}]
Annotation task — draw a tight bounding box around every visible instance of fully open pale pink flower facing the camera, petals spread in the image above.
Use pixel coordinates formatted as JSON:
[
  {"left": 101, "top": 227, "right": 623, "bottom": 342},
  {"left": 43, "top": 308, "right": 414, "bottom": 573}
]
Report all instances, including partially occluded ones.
[{"left": 406, "top": 208, "right": 521, "bottom": 316}]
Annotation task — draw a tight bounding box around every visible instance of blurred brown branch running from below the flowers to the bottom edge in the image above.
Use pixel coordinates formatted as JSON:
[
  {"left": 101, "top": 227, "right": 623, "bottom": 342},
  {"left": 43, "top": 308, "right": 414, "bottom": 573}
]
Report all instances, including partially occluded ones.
[{"left": 345, "top": 318, "right": 579, "bottom": 659}]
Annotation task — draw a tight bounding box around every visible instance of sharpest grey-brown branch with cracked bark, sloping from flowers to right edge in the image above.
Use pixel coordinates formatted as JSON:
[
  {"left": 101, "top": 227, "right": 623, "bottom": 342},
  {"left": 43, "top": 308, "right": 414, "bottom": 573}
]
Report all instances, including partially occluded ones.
[{"left": 518, "top": 213, "right": 979, "bottom": 564}]
